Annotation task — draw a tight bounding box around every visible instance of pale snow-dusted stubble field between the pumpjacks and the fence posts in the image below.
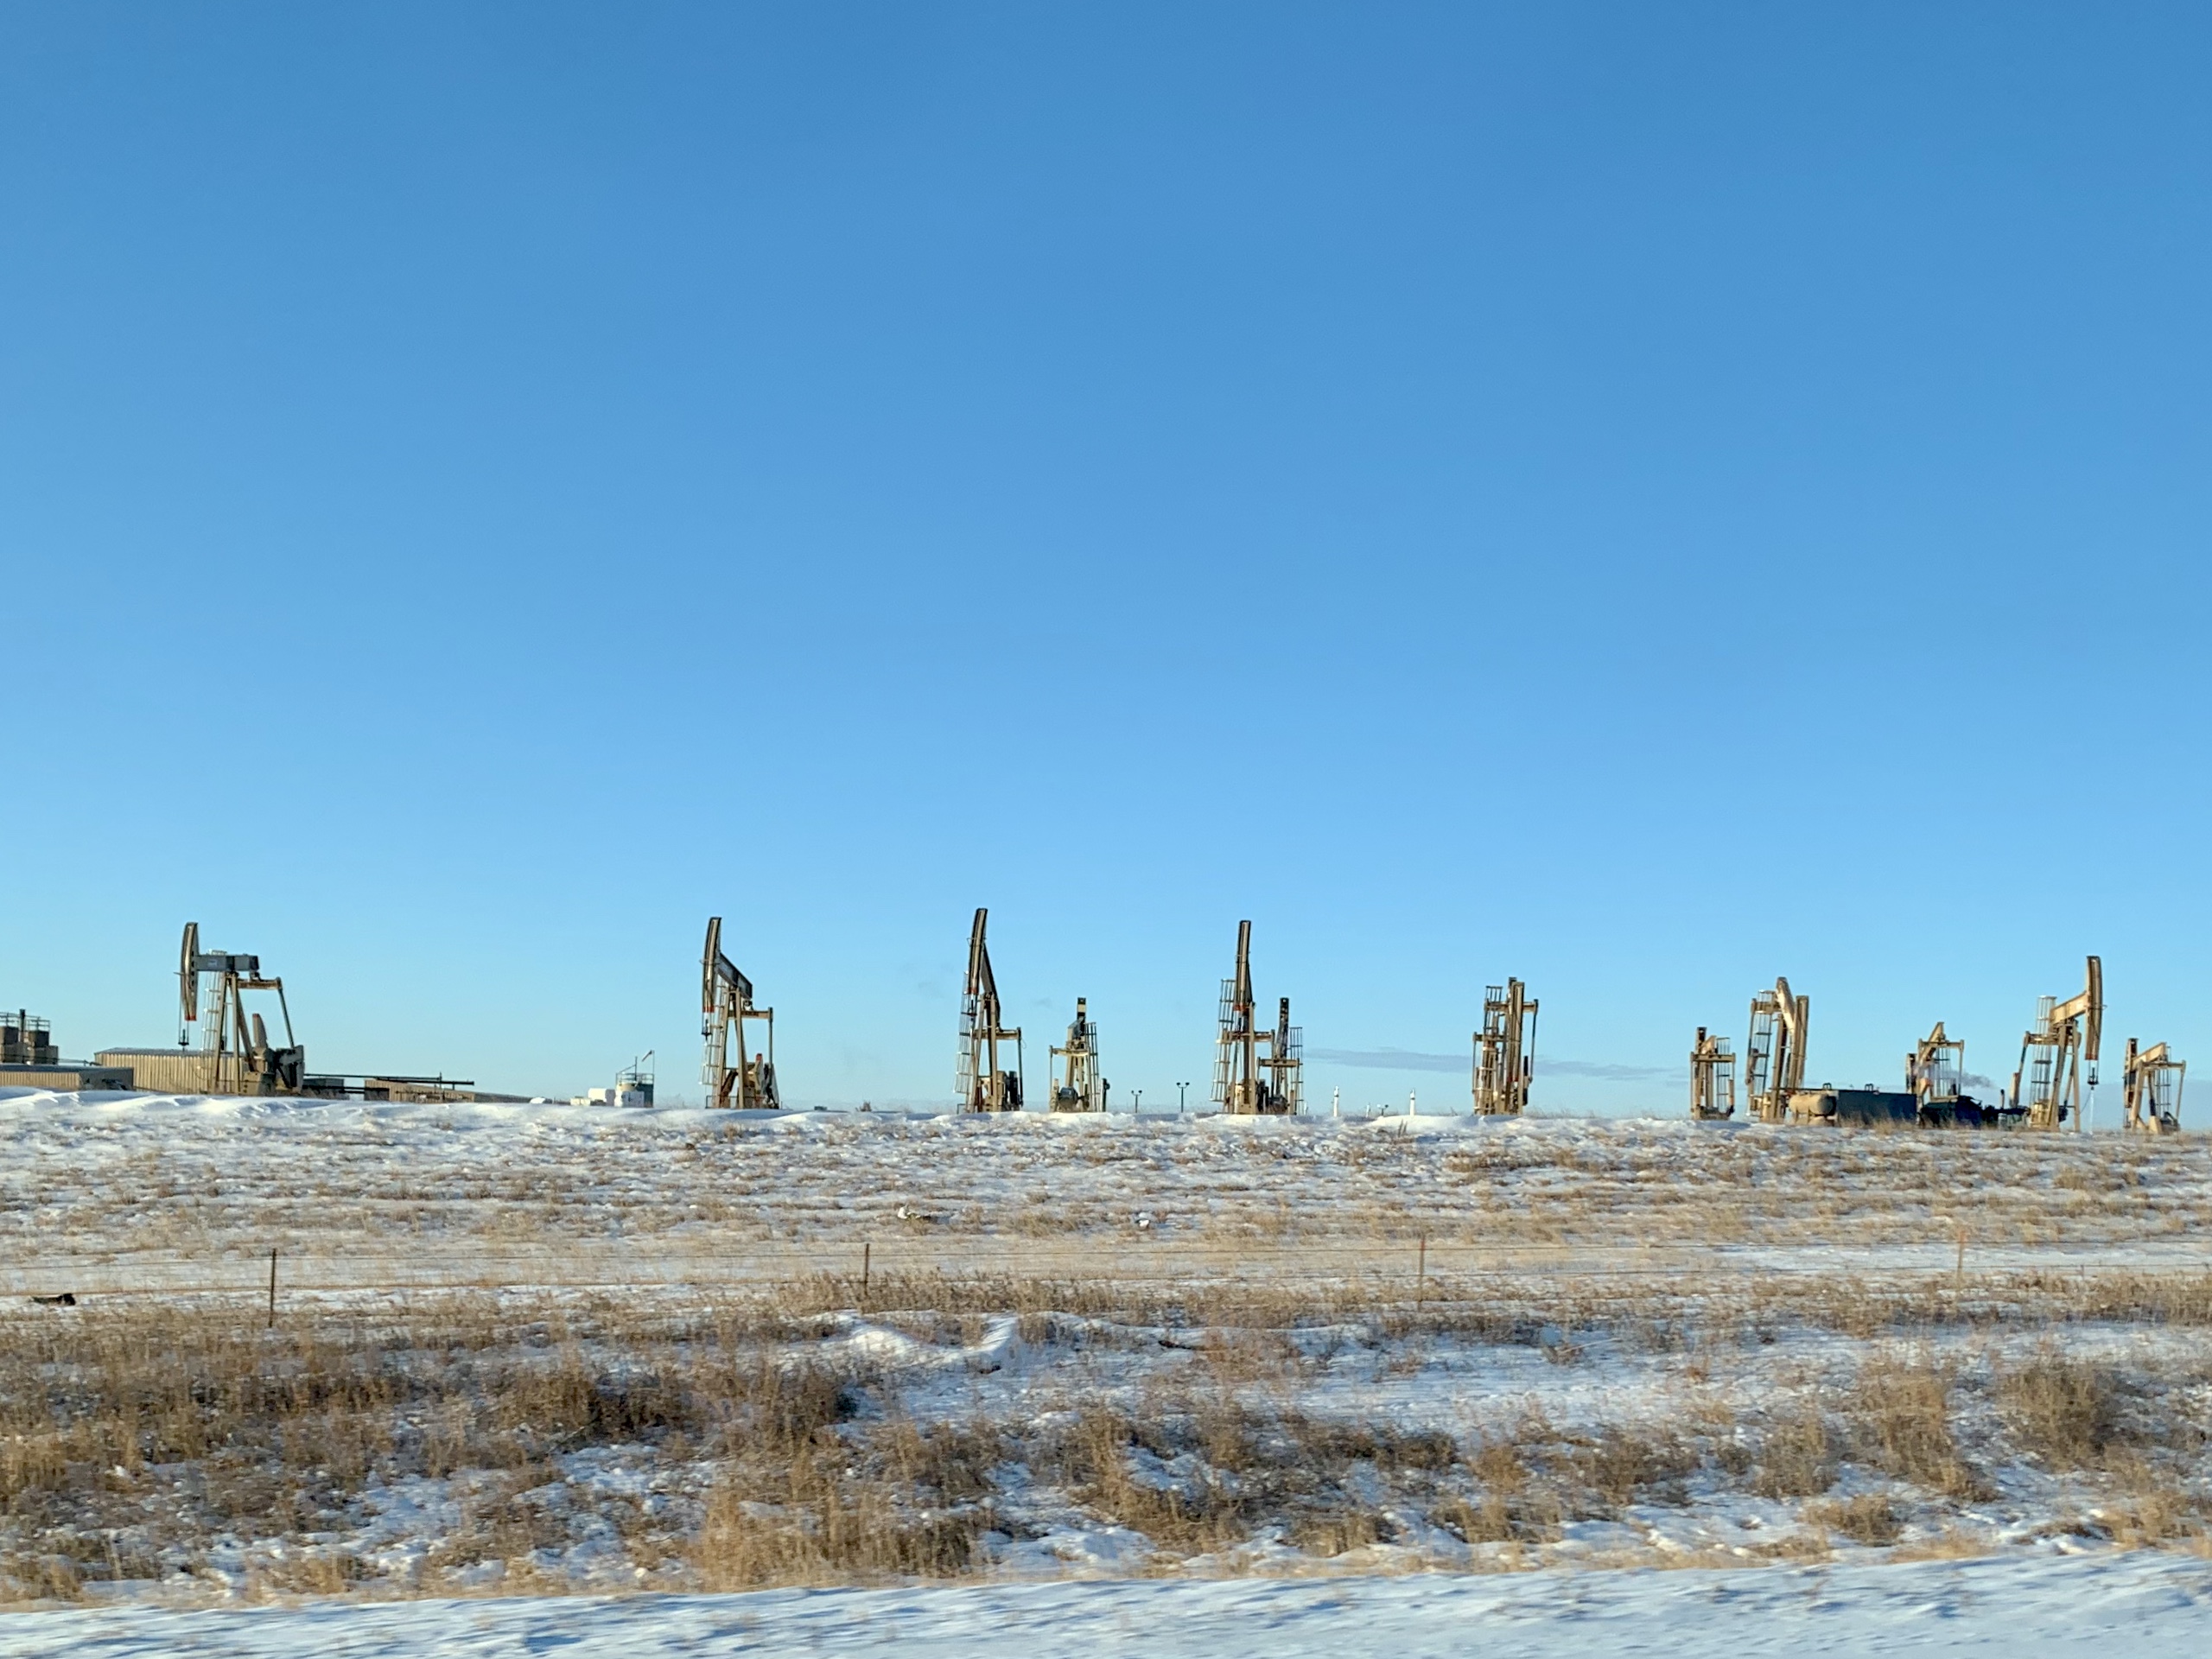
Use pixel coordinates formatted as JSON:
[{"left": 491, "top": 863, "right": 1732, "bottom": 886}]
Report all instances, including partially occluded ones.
[{"left": 0, "top": 1093, "right": 2212, "bottom": 1294}]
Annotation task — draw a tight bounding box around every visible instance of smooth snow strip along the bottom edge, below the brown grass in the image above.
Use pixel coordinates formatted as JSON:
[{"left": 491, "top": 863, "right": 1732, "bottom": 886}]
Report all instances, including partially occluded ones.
[{"left": 0, "top": 1555, "right": 2212, "bottom": 1659}]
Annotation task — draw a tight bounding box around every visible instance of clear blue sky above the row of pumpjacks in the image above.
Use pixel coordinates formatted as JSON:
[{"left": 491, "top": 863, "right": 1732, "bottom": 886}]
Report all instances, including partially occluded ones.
[{"left": 0, "top": 3, "right": 2212, "bottom": 1115}]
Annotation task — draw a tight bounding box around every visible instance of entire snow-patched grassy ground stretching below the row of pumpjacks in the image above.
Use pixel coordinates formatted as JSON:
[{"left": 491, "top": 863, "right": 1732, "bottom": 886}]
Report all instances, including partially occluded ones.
[{"left": 0, "top": 1095, "right": 2212, "bottom": 1652}]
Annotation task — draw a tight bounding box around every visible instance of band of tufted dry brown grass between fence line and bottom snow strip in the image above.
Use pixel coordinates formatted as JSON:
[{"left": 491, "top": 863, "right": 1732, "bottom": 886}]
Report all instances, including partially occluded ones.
[{"left": 0, "top": 1274, "right": 2212, "bottom": 1599}]
